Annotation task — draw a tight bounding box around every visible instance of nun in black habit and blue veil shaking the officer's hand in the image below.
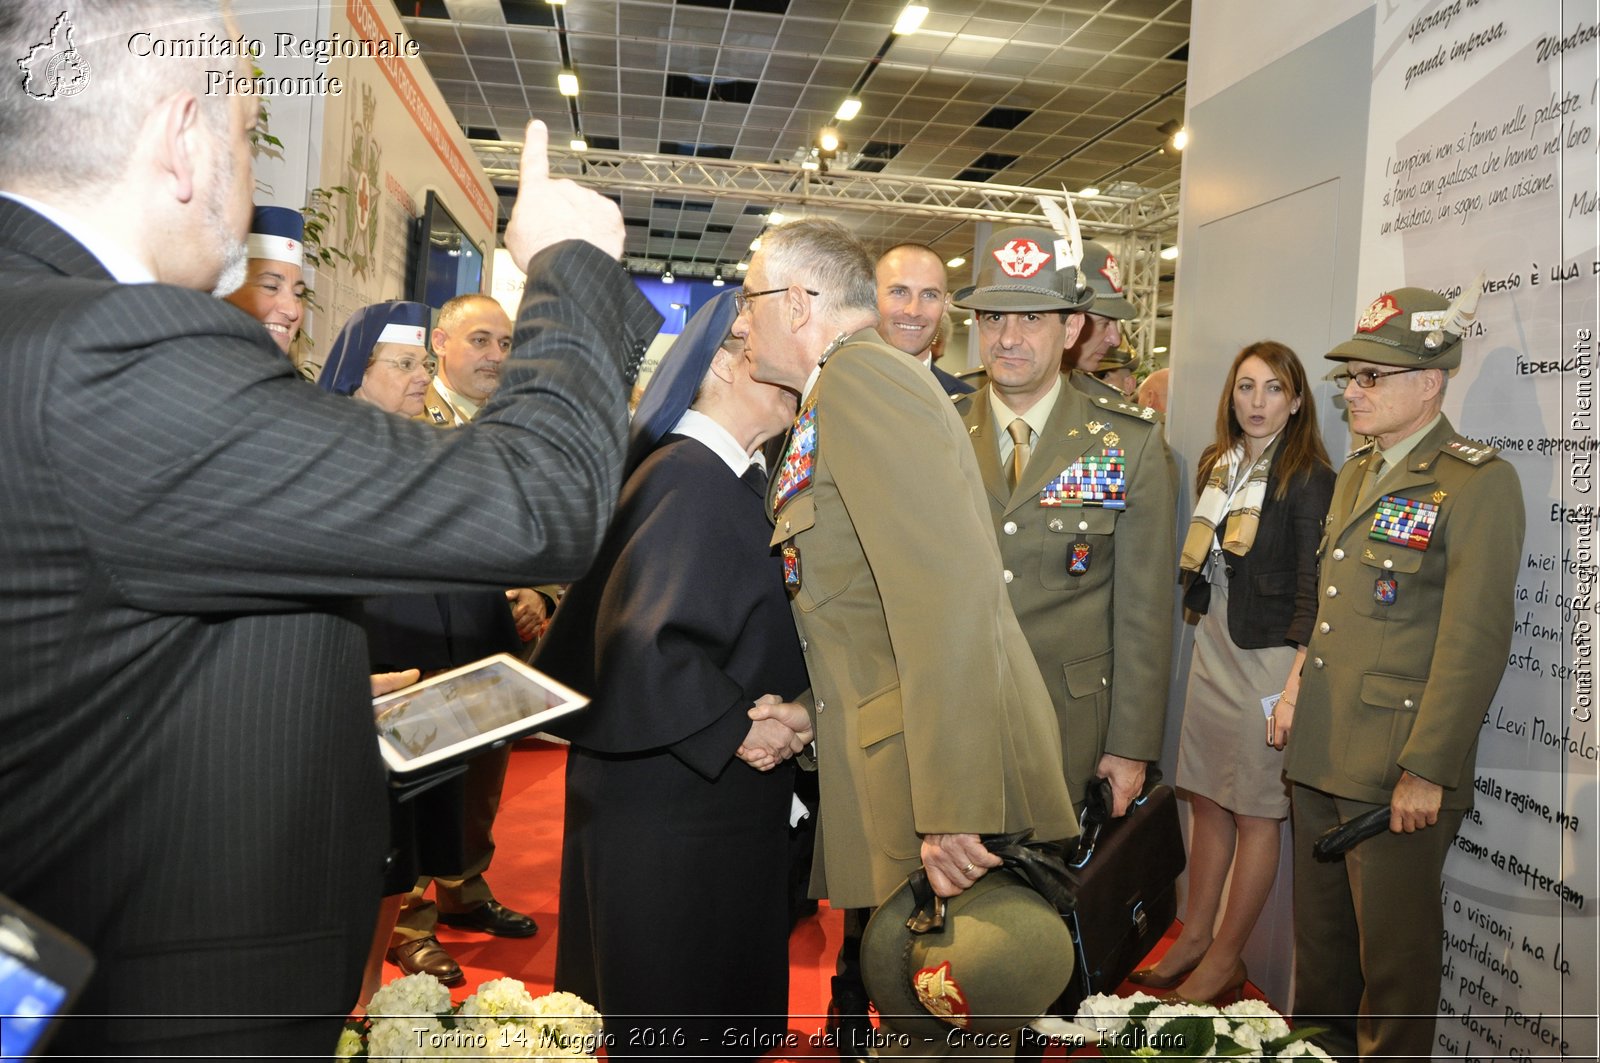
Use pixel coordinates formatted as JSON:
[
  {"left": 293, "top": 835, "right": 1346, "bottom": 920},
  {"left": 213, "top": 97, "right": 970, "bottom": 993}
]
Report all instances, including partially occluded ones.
[{"left": 534, "top": 293, "right": 811, "bottom": 1060}]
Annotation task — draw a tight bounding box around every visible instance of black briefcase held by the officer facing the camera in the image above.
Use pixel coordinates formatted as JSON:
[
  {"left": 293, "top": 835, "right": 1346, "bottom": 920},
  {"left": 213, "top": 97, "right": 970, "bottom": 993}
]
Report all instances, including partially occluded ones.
[{"left": 1051, "top": 768, "right": 1184, "bottom": 1018}]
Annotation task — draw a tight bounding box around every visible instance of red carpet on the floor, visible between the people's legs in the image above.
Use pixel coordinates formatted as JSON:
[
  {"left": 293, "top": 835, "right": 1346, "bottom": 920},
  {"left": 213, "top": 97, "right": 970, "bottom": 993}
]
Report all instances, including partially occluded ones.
[{"left": 396, "top": 741, "right": 1264, "bottom": 1060}]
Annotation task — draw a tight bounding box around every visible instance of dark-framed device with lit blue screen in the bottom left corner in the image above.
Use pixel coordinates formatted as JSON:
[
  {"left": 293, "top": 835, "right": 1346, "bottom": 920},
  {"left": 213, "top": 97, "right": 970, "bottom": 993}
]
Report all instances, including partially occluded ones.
[{"left": 0, "top": 895, "right": 94, "bottom": 1060}]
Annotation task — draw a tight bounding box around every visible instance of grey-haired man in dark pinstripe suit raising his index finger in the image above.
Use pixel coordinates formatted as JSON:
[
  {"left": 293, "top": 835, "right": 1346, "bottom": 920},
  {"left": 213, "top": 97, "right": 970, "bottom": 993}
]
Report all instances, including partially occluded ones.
[{"left": 0, "top": 0, "right": 659, "bottom": 1058}]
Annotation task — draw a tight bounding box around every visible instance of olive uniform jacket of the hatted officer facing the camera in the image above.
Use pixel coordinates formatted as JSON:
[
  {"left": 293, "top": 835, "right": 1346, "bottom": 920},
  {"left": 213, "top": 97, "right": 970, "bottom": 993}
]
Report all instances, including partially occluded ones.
[{"left": 957, "top": 378, "right": 1178, "bottom": 802}]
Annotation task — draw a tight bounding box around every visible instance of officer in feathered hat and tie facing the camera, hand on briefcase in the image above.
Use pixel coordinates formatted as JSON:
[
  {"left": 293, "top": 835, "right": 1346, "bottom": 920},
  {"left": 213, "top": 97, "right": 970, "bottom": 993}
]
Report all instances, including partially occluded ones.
[{"left": 955, "top": 226, "right": 1178, "bottom": 815}]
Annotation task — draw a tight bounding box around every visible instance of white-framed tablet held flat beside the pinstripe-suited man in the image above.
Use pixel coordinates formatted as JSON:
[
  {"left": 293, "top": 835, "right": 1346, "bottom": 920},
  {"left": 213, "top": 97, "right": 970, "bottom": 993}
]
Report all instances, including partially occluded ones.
[{"left": 373, "top": 653, "right": 589, "bottom": 778}]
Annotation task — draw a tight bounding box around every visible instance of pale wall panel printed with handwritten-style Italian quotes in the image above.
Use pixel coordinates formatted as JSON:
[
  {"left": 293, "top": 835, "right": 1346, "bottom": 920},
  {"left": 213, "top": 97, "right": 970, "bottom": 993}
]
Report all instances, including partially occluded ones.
[{"left": 1352, "top": 0, "right": 1600, "bottom": 1060}]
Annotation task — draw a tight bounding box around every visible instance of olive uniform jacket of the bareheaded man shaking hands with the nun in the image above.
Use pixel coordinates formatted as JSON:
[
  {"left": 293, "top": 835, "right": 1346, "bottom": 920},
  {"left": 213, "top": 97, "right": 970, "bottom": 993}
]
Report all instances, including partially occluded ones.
[{"left": 770, "top": 328, "right": 1077, "bottom": 908}]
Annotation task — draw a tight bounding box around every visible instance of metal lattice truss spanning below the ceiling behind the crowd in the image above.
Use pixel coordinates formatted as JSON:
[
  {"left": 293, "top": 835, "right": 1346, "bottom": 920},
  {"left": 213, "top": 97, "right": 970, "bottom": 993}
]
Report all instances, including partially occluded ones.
[{"left": 472, "top": 141, "right": 1178, "bottom": 357}]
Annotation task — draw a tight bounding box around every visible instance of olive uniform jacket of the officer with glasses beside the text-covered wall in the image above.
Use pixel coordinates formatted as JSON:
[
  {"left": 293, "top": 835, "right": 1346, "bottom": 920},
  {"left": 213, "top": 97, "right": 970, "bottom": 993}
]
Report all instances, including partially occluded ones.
[{"left": 1285, "top": 418, "right": 1525, "bottom": 808}]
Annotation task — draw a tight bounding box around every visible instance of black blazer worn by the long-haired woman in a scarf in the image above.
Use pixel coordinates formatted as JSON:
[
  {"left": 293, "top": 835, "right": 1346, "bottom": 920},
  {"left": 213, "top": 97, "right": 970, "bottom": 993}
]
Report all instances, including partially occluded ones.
[{"left": 1184, "top": 453, "right": 1333, "bottom": 650}]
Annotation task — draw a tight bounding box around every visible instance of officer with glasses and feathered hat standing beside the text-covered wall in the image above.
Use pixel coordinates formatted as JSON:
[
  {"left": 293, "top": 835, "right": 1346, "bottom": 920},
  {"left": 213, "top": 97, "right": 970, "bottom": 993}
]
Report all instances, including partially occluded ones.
[{"left": 1277, "top": 288, "right": 1523, "bottom": 1058}]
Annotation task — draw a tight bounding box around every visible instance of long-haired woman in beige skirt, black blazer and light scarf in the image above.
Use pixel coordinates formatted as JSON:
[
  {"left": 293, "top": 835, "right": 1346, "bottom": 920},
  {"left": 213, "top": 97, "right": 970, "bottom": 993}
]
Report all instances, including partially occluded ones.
[{"left": 1131, "top": 341, "right": 1333, "bottom": 1001}]
